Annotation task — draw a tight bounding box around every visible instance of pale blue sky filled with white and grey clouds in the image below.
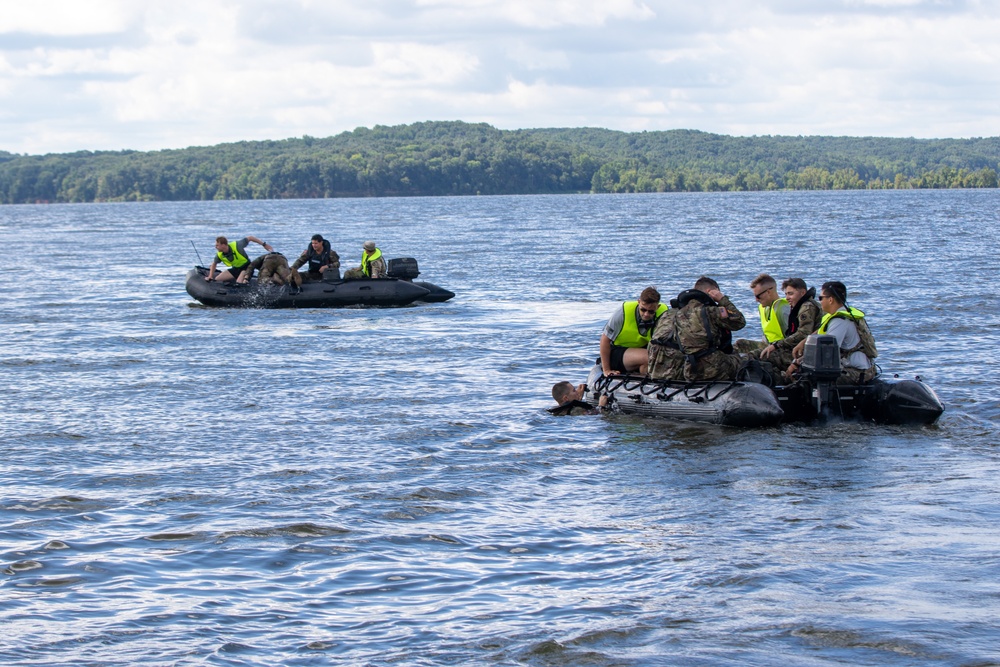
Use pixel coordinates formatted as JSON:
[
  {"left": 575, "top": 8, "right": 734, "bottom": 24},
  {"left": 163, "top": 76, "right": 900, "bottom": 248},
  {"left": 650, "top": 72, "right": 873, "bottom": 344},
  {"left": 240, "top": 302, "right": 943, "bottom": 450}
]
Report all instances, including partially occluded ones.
[{"left": 0, "top": 0, "right": 1000, "bottom": 154}]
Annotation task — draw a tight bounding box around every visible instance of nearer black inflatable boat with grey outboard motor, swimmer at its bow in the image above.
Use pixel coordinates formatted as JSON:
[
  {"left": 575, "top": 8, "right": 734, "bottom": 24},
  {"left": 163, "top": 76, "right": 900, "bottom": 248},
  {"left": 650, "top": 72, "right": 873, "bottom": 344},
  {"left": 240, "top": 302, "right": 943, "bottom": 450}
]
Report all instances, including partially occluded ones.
[{"left": 586, "top": 336, "right": 944, "bottom": 427}]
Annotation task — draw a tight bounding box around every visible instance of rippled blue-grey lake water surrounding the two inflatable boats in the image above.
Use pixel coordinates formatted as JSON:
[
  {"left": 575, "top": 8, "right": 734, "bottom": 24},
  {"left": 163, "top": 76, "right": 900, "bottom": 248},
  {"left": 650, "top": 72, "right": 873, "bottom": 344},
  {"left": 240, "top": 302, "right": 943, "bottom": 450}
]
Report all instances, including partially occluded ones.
[{"left": 0, "top": 191, "right": 1000, "bottom": 666}]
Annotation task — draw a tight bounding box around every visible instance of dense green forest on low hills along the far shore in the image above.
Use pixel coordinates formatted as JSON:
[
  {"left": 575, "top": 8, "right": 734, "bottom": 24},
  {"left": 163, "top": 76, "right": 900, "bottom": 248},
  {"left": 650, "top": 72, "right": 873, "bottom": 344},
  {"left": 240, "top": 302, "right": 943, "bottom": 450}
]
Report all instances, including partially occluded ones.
[{"left": 0, "top": 121, "right": 1000, "bottom": 204}]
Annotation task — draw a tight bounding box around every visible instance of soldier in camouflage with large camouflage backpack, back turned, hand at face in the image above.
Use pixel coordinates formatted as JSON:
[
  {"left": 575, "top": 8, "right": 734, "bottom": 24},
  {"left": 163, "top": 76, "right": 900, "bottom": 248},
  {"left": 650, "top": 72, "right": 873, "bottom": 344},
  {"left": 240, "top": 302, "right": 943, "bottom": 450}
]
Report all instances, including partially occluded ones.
[{"left": 649, "top": 276, "right": 746, "bottom": 382}]
